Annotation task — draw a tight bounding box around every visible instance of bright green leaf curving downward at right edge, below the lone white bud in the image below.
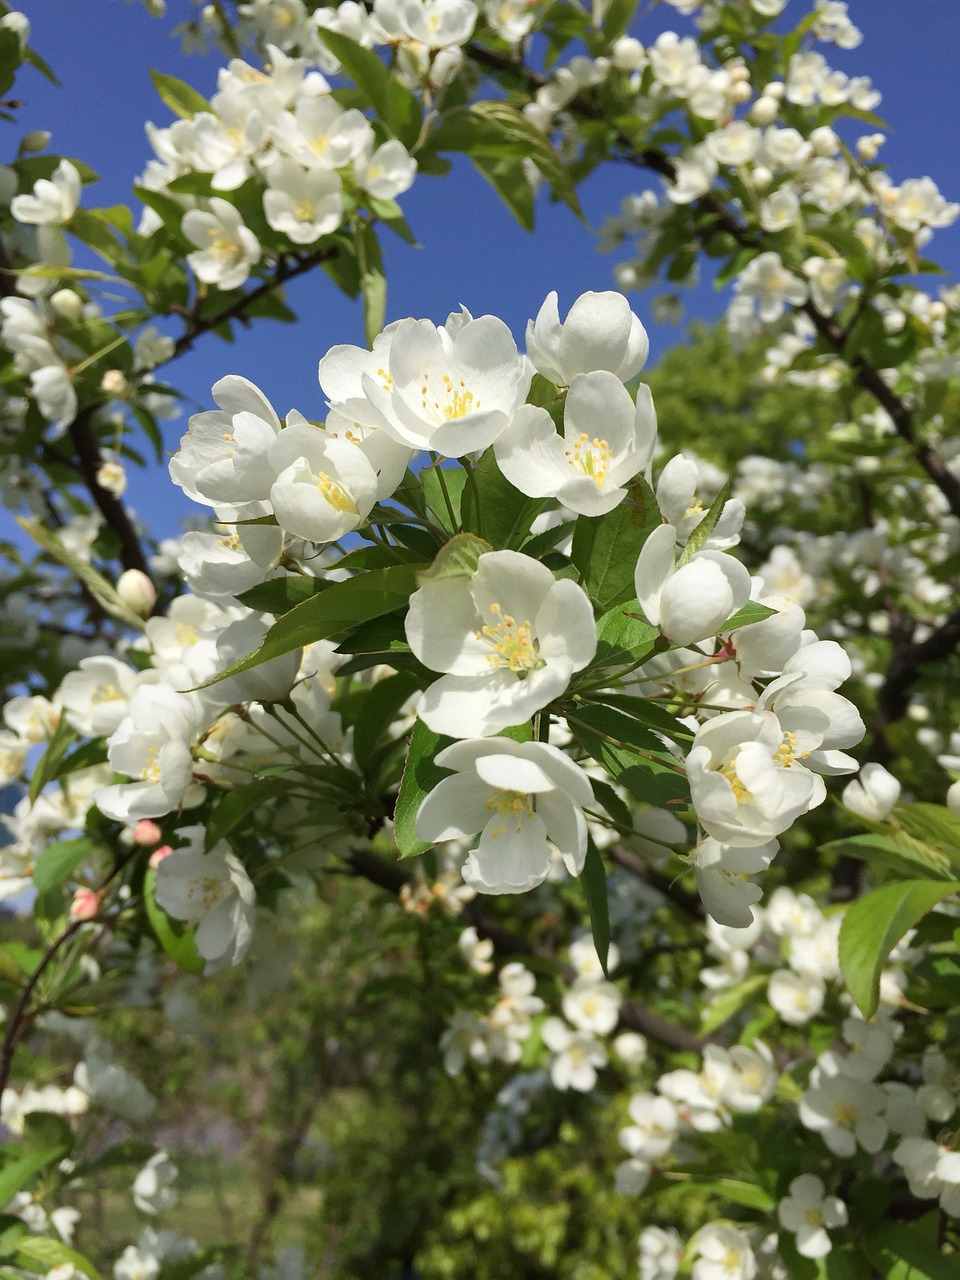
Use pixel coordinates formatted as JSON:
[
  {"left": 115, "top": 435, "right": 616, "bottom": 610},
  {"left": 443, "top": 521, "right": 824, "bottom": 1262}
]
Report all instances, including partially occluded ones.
[{"left": 840, "top": 881, "right": 960, "bottom": 1018}]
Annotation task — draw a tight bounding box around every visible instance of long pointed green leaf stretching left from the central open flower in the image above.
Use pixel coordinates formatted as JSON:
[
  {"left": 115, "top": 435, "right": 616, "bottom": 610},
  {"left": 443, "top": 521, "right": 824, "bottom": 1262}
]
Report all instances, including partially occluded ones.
[{"left": 201, "top": 564, "right": 416, "bottom": 689}]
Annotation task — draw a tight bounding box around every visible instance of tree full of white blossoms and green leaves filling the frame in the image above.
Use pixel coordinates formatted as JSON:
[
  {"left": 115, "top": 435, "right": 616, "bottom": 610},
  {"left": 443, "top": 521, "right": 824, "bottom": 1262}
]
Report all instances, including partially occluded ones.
[{"left": 0, "top": 0, "right": 960, "bottom": 1280}]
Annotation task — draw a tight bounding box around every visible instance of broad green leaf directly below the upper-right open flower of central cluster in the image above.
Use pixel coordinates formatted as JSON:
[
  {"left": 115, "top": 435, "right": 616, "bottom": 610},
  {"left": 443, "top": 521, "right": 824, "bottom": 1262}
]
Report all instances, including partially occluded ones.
[{"left": 571, "top": 476, "right": 662, "bottom": 612}]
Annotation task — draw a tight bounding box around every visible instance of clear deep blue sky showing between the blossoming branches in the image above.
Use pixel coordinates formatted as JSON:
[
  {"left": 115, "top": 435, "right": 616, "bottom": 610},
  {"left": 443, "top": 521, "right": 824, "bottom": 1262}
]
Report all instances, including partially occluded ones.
[{"left": 6, "top": 0, "right": 960, "bottom": 532}]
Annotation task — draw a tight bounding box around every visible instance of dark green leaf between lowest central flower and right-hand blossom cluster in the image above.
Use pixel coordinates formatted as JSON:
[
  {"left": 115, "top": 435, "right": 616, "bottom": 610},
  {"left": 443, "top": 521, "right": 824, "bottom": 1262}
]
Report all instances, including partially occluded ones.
[{"left": 567, "top": 705, "right": 690, "bottom": 805}]
